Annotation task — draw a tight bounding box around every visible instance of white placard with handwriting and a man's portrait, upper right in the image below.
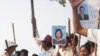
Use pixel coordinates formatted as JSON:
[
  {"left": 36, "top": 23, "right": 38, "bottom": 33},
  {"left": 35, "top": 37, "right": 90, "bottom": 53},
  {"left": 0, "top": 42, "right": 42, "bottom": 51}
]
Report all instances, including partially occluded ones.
[{"left": 77, "top": 0, "right": 99, "bottom": 29}]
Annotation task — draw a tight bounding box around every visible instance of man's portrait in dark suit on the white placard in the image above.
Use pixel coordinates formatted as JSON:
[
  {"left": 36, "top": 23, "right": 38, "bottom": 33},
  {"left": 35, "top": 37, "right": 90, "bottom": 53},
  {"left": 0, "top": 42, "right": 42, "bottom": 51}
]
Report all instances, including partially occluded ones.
[{"left": 78, "top": 4, "right": 89, "bottom": 20}]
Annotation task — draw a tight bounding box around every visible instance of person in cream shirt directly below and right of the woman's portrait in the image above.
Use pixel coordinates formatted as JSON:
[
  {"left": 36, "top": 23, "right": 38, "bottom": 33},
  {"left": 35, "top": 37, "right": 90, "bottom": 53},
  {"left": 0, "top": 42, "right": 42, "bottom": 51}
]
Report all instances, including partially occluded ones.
[{"left": 54, "top": 36, "right": 73, "bottom": 56}]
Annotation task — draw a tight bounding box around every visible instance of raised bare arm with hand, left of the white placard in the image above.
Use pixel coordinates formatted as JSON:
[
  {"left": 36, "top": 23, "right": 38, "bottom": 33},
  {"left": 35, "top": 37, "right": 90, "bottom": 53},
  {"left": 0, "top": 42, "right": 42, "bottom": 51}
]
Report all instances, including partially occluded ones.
[{"left": 69, "top": 0, "right": 87, "bottom": 37}]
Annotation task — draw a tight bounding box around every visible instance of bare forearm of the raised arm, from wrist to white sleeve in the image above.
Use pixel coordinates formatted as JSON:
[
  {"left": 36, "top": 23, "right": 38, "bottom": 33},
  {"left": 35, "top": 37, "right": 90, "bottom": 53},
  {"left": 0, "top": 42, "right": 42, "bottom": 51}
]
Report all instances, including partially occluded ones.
[{"left": 73, "top": 8, "right": 87, "bottom": 36}]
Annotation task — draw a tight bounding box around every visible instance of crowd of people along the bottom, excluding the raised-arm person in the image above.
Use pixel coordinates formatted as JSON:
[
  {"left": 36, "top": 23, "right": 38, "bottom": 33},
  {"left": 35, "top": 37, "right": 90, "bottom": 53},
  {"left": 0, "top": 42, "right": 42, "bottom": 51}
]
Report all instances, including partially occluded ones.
[{"left": 2, "top": 33, "right": 96, "bottom": 56}]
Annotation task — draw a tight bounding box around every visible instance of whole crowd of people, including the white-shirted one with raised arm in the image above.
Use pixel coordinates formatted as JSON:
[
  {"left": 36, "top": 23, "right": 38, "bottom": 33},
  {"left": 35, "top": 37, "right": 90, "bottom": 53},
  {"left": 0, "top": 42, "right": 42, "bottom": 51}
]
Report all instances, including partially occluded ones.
[{"left": 2, "top": 0, "right": 100, "bottom": 56}]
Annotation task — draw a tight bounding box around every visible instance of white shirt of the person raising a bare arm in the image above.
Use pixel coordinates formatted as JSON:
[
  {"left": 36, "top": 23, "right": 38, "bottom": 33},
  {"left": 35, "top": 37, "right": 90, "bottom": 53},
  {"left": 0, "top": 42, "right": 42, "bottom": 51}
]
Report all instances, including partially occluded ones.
[{"left": 88, "top": 29, "right": 100, "bottom": 56}]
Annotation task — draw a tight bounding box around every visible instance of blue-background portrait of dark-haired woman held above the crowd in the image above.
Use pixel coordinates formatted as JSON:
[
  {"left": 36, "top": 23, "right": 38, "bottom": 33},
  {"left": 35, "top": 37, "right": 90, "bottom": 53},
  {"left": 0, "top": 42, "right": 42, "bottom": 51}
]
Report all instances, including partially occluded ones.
[{"left": 52, "top": 26, "right": 66, "bottom": 45}]
